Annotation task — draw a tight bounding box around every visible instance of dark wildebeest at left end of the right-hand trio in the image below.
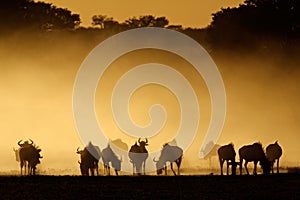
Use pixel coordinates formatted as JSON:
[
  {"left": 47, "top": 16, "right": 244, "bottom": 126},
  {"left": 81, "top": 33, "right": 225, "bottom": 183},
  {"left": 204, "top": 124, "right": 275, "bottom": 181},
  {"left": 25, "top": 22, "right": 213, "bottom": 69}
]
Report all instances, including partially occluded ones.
[{"left": 218, "top": 143, "right": 236, "bottom": 175}]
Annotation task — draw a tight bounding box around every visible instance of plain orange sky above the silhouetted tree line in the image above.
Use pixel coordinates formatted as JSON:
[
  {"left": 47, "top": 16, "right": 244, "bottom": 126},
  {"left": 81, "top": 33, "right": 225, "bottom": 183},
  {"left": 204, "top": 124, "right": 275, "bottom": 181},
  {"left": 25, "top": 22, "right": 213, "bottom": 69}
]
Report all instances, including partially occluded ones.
[{"left": 44, "top": 0, "right": 243, "bottom": 28}]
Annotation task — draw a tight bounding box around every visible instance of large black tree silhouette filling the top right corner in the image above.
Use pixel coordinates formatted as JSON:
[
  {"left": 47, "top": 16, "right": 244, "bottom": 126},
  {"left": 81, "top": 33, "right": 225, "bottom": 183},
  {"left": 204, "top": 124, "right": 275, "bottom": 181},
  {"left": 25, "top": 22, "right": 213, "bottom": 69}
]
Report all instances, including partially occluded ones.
[{"left": 208, "top": 0, "right": 300, "bottom": 51}]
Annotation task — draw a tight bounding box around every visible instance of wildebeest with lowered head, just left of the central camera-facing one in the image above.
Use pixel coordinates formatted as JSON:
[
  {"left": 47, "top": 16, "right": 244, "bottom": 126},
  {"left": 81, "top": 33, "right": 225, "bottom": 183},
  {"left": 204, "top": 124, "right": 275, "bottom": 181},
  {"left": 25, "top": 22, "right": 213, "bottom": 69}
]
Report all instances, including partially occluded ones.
[{"left": 102, "top": 144, "right": 122, "bottom": 176}]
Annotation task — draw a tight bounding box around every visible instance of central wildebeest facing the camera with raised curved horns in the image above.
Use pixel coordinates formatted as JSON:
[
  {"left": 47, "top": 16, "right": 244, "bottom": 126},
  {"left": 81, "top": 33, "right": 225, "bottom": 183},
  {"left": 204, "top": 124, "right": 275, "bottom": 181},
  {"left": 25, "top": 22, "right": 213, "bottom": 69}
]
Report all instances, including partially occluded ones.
[{"left": 128, "top": 138, "right": 148, "bottom": 175}]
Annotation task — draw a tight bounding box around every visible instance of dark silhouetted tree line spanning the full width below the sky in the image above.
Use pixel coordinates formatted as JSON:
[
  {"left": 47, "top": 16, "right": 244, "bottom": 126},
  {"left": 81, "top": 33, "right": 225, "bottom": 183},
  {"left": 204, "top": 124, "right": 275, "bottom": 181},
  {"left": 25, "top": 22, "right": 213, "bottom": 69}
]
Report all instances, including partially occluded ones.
[{"left": 0, "top": 0, "right": 300, "bottom": 52}]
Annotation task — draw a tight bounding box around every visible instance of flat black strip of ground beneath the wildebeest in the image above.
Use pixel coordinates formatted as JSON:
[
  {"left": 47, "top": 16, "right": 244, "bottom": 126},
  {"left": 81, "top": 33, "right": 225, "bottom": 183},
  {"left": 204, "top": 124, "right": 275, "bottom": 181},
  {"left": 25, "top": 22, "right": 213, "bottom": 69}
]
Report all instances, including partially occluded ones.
[{"left": 0, "top": 174, "right": 300, "bottom": 200}]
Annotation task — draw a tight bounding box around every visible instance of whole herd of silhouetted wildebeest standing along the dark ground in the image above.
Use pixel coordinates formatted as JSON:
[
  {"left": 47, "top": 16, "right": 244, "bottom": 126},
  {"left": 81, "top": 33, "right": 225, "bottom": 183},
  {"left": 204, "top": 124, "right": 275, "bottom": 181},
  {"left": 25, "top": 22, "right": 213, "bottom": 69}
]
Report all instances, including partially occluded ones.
[{"left": 14, "top": 138, "right": 282, "bottom": 176}]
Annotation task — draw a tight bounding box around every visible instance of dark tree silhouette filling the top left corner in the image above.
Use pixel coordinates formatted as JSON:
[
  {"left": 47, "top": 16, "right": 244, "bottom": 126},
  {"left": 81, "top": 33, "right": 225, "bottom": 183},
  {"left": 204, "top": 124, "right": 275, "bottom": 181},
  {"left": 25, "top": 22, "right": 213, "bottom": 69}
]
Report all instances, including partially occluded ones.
[{"left": 0, "top": 0, "right": 80, "bottom": 32}]
